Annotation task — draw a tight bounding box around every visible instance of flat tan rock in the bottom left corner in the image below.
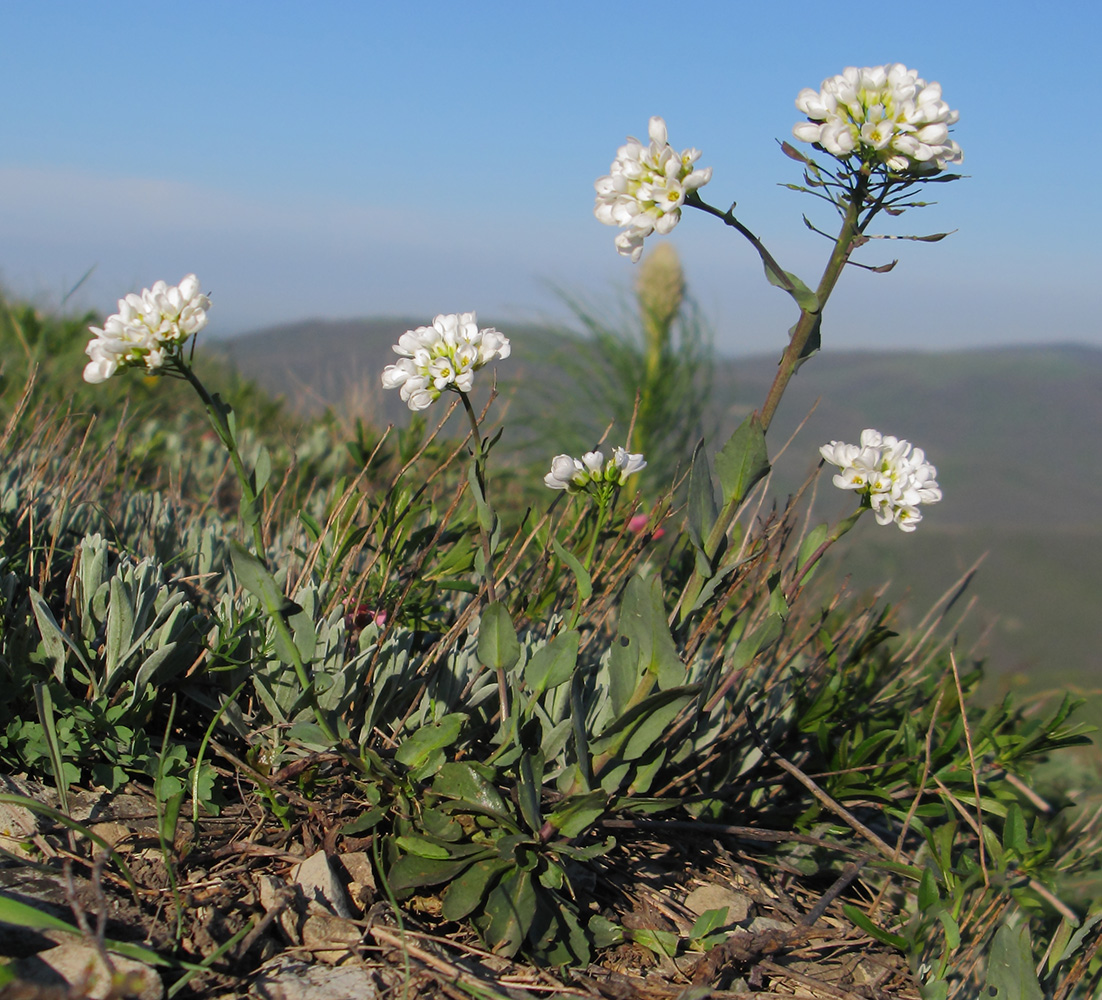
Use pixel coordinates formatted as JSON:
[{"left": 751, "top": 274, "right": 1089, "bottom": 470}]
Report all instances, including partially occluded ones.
[{"left": 9, "top": 940, "right": 164, "bottom": 1000}]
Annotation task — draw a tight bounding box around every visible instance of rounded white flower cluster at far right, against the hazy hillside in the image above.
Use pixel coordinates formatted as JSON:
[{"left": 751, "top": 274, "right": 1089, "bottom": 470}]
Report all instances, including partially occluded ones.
[{"left": 819, "top": 429, "right": 941, "bottom": 531}]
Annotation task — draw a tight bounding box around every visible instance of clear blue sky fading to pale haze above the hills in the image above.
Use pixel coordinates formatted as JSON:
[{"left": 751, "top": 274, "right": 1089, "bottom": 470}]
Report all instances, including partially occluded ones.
[{"left": 0, "top": 0, "right": 1102, "bottom": 354}]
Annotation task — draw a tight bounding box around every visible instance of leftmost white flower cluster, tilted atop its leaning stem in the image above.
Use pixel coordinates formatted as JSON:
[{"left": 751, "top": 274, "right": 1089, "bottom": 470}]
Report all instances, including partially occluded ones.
[{"left": 84, "top": 275, "right": 210, "bottom": 384}]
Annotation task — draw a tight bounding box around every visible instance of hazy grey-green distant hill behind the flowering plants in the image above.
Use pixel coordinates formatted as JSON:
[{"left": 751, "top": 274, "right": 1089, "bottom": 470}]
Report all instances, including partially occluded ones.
[{"left": 217, "top": 318, "right": 1102, "bottom": 701}]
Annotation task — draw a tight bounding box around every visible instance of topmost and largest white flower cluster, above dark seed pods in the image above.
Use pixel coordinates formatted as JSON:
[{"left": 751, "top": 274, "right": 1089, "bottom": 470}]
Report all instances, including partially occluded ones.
[{"left": 792, "top": 63, "right": 964, "bottom": 173}]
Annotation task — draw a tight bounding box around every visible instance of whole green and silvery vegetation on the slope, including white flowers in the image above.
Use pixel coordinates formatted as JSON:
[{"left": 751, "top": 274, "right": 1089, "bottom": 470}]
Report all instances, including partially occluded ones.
[{"left": 0, "top": 60, "right": 1102, "bottom": 998}]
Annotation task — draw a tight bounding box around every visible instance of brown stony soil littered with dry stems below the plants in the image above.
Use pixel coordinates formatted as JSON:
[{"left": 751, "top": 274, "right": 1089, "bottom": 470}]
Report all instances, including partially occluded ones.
[{"left": 0, "top": 766, "right": 919, "bottom": 1000}]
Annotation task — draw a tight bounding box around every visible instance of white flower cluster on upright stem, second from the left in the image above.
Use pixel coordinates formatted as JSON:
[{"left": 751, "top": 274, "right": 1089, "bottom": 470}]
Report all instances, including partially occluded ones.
[{"left": 382, "top": 312, "right": 511, "bottom": 410}]
